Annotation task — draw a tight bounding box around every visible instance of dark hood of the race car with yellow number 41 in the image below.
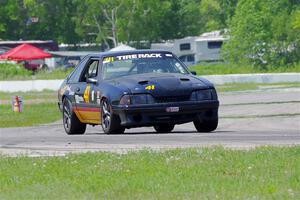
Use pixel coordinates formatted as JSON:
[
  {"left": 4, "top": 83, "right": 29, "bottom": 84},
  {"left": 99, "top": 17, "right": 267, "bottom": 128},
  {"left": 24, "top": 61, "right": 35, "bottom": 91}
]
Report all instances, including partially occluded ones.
[{"left": 105, "top": 73, "right": 212, "bottom": 96}]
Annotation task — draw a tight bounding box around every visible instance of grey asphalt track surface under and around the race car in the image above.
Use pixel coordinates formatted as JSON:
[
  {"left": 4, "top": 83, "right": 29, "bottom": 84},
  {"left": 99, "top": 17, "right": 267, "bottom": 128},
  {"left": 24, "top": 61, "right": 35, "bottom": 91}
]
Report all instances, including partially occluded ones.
[{"left": 0, "top": 88, "right": 300, "bottom": 156}]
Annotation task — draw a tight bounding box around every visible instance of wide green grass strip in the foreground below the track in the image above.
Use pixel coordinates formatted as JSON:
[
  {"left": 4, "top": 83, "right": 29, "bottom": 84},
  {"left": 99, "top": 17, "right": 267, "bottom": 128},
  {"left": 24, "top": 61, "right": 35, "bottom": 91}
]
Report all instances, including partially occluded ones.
[{"left": 0, "top": 146, "right": 300, "bottom": 200}]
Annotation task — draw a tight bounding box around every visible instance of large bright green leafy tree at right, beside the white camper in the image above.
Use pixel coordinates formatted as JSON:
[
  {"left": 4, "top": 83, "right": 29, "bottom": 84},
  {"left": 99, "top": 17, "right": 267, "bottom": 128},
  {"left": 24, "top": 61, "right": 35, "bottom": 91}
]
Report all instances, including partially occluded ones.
[{"left": 223, "top": 0, "right": 299, "bottom": 67}]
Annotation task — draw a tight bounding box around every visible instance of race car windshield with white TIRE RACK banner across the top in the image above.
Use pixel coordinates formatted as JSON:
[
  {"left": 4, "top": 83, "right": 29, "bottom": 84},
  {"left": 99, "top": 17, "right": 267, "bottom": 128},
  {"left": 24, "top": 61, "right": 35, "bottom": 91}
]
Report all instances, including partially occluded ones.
[{"left": 103, "top": 53, "right": 189, "bottom": 79}]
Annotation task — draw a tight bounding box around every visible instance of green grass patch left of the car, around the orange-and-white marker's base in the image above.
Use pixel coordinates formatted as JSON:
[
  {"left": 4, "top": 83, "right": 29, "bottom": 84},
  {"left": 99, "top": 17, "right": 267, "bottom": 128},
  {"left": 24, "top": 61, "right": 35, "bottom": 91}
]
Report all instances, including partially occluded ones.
[{"left": 0, "top": 103, "right": 61, "bottom": 128}]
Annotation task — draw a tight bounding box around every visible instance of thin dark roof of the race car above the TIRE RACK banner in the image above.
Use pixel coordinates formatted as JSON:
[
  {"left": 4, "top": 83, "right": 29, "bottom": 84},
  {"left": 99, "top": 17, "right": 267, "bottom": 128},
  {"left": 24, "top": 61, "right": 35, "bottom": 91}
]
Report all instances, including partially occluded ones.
[{"left": 88, "top": 49, "right": 172, "bottom": 57}]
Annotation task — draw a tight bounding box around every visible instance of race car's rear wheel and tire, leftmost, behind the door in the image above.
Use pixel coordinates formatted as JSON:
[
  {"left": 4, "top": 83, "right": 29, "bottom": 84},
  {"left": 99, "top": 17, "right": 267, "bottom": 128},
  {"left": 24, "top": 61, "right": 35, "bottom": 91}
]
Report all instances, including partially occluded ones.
[{"left": 62, "top": 98, "right": 86, "bottom": 135}]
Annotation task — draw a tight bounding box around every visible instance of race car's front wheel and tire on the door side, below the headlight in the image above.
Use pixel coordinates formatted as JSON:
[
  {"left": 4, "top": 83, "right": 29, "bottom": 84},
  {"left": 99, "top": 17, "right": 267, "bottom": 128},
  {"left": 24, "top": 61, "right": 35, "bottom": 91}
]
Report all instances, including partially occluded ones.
[{"left": 101, "top": 100, "right": 125, "bottom": 134}]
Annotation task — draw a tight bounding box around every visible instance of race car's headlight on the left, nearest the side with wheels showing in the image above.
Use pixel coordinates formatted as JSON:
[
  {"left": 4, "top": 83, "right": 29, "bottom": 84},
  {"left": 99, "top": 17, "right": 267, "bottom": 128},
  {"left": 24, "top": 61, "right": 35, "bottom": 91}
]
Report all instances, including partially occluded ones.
[{"left": 120, "top": 94, "right": 155, "bottom": 105}]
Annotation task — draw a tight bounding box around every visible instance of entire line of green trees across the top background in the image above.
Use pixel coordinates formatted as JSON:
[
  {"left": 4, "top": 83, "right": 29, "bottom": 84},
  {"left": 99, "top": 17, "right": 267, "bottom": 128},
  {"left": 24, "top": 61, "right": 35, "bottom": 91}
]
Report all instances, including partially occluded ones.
[{"left": 0, "top": 0, "right": 300, "bottom": 67}]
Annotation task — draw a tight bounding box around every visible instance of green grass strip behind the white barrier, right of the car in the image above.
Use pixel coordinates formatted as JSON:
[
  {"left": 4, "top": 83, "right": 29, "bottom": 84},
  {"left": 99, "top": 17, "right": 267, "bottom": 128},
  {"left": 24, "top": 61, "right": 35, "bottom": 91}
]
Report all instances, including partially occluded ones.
[{"left": 189, "top": 63, "right": 300, "bottom": 75}]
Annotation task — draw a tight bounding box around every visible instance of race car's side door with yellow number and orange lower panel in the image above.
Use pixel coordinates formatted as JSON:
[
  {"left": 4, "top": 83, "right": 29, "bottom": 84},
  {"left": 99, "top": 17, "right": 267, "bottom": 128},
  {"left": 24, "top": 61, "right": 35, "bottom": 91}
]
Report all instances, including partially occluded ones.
[{"left": 75, "top": 57, "right": 100, "bottom": 124}]
